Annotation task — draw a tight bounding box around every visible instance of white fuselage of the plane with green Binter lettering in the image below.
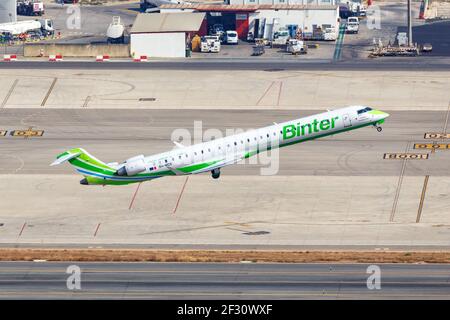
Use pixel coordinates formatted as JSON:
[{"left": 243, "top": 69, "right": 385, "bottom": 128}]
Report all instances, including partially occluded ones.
[{"left": 125, "top": 106, "right": 388, "bottom": 174}]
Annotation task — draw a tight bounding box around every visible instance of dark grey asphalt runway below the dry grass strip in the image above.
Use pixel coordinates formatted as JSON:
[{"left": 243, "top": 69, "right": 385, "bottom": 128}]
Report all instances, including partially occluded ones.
[{"left": 0, "top": 262, "right": 450, "bottom": 300}]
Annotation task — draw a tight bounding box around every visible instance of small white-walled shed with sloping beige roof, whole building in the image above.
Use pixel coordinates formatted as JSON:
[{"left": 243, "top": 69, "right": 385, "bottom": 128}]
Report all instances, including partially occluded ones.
[{"left": 130, "top": 12, "right": 205, "bottom": 58}]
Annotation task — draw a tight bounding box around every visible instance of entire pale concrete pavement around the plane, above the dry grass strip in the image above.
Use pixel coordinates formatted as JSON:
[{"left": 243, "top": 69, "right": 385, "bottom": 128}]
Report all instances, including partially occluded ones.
[{"left": 0, "top": 66, "right": 450, "bottom": 250}]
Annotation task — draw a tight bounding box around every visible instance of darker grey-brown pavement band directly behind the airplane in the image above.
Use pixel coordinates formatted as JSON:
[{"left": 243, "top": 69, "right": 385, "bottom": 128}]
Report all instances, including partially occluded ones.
[{"left": 0, "top": 109, "right": 450, "bottom": 176}]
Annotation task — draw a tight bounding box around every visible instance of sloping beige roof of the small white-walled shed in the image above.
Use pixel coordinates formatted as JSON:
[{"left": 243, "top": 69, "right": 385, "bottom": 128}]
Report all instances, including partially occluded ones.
[{"left": 130, "top": 12, "right": 205, "bottom": 33}]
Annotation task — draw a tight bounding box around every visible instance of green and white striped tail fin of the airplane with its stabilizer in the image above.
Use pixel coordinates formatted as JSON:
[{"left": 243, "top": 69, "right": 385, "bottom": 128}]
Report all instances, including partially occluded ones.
[{"left": 50, "top": 148, "right": 116, "bottom": 175}]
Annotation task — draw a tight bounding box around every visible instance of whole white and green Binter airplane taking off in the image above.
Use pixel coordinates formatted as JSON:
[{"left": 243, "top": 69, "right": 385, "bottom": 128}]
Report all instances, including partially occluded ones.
[{"left": 51, "top": 106, "right": 389, "bottom": 185}]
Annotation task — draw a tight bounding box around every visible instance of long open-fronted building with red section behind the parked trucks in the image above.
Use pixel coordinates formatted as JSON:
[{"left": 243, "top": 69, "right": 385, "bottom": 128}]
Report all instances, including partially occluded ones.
[{"left": 160, "top": 4, "right": 339, "bottom": 40}]
